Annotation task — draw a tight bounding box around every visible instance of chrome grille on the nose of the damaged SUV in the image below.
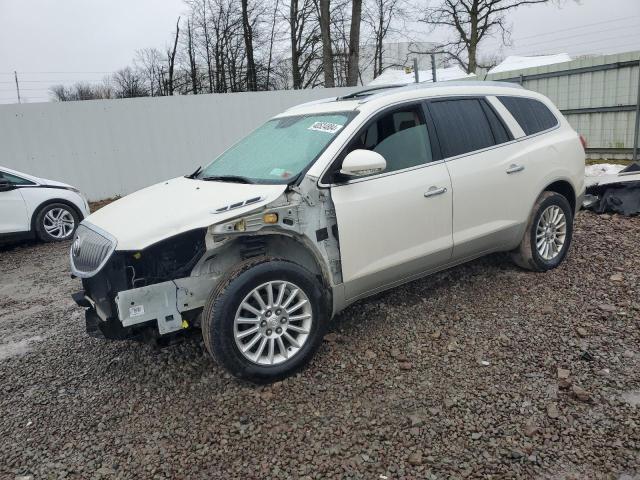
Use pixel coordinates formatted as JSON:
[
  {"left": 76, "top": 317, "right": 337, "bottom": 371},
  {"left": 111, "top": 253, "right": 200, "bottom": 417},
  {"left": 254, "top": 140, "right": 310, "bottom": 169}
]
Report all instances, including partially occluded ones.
[{"left": 69, "top": 223, "right": 116, "bottom": 277}]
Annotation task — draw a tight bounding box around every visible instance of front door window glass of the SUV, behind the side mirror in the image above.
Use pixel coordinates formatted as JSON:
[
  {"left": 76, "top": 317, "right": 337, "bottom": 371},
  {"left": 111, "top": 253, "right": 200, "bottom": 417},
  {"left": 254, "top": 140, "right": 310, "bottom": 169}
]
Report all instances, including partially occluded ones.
[{"left": 346, "top": 105, "right": 433, "bottom": 172}]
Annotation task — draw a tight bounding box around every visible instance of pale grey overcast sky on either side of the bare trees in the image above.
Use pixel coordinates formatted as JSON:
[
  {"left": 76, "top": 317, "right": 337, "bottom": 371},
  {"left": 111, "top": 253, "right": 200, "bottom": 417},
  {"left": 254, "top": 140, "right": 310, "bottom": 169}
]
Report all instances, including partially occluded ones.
[{"left": 0, "top": 0, "right": 640, "bottom": 103}]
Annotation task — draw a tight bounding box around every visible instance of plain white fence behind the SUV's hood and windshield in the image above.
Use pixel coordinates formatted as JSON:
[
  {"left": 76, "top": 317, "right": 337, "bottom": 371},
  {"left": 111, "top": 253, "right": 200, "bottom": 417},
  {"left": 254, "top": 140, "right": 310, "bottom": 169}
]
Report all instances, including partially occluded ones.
[{"left": 0, "top": 88, "right": 354, "bottom": 200}]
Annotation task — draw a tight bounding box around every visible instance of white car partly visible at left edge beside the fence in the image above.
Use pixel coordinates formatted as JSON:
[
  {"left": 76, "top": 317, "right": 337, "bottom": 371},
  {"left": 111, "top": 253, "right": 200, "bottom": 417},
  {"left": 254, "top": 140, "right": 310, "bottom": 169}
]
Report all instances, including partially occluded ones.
[{"left": 0, "top": 166, "right": 89, "bottom": 242}]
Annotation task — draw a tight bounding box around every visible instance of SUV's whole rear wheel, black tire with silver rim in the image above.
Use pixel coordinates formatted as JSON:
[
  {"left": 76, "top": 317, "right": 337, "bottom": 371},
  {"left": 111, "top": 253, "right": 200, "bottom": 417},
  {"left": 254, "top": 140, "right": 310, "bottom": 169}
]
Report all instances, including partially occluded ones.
[{"left": 511, "top": 192, "right": 573, "bottom": 272}]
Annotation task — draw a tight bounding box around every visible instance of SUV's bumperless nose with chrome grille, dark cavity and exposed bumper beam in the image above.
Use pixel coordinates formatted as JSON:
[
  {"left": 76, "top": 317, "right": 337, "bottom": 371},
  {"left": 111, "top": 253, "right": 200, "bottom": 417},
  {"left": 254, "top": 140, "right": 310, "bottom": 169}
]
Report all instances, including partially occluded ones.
[{"left": 70, "top": 223, "right": 206, "bottom": 340}]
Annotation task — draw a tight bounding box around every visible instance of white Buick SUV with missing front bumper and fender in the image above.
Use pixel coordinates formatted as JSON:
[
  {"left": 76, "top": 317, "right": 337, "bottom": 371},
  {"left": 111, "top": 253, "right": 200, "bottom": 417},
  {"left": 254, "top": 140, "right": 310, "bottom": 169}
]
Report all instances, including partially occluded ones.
[{"left": 70, "top": 82, "right": 584, "bottom": 382}]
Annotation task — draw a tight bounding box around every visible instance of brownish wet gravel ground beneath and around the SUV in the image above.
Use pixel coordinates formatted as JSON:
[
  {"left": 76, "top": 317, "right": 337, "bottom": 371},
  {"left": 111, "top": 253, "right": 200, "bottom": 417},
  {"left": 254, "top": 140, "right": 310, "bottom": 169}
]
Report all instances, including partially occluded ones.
[{"left": 0, "top": 213, "right": 640, "bottom": 480}]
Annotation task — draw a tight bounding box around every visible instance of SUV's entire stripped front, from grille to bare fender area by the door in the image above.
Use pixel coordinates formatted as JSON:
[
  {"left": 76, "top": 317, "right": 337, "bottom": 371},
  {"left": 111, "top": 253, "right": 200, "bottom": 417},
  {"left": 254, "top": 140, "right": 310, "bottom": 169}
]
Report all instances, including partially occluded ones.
[{"left": 70, "top": 181, "right": 341, "bottom": 341}]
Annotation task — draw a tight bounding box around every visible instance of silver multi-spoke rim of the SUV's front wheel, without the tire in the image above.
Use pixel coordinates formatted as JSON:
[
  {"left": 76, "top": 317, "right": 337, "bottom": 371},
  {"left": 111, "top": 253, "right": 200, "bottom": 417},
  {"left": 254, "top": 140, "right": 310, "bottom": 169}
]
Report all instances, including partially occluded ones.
[{"left": 233, "top": 280, "right": 313, "bottom": 365}]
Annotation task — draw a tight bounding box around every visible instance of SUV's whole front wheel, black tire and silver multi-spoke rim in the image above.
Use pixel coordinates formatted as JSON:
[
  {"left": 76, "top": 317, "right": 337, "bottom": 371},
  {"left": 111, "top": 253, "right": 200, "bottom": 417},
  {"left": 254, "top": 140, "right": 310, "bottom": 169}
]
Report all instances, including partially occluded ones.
[{"left": 202, "top": 257, "right": 328, "bottom": 383}]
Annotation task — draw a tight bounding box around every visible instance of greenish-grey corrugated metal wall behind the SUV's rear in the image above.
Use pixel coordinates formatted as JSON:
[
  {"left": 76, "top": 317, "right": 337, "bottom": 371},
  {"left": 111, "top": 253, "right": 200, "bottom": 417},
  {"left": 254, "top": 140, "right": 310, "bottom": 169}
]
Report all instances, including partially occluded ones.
[{"left": 486, "top": 52, "right": 640, "bottom": 158}]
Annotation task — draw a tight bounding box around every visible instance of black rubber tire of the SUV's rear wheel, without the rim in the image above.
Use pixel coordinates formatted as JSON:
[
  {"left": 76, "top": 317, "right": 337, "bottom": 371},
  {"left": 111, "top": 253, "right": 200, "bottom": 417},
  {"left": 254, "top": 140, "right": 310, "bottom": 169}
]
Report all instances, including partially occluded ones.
[{"left": 511, "top": 192, "right": 573, "bottom": 272}]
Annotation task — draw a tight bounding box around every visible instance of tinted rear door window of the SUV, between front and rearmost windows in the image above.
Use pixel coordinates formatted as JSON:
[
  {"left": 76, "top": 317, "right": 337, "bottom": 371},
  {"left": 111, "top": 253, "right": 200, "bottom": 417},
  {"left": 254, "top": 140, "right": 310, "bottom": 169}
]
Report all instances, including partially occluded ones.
[{"left": 429, "top": 98, "right": 509, "bottom": 158}]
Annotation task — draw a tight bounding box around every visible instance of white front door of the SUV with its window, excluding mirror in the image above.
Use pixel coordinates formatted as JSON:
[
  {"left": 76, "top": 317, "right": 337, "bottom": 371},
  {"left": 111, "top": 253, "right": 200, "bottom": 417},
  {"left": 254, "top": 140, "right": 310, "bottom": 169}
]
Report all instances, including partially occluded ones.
[{"left": 331, "top": 104, "right": 453, "bottom": 300}]
